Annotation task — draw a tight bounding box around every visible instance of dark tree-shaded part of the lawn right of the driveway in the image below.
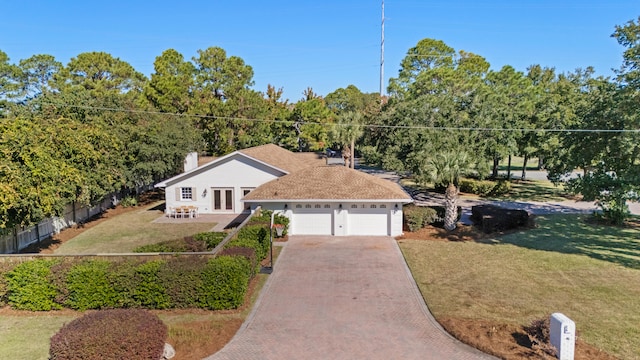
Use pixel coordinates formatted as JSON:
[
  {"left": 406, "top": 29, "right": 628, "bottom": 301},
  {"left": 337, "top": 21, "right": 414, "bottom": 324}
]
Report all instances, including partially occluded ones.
[{"left": 480, "top": 214, "right": 640, "bottom": 269}]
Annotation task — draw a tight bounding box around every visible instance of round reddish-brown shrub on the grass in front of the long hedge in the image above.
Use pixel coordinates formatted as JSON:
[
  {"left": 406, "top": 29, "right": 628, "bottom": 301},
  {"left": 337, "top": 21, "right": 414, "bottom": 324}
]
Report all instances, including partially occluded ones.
[{"left": 49, "top": 309, "right": 168, "bottom": 360}]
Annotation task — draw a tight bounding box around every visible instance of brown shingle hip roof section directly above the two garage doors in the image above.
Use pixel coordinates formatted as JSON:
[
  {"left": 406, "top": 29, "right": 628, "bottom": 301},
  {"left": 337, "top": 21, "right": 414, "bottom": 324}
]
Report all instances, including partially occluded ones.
[{"left": 244, "top": 165, "right": 411, "bottom": 202}]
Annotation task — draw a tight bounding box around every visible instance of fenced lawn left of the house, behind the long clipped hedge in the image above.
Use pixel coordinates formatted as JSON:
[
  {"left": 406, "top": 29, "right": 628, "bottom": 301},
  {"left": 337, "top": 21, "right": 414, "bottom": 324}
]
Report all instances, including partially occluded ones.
[{"left": 55, "top": 202, "right": 215, "bottom": 255}]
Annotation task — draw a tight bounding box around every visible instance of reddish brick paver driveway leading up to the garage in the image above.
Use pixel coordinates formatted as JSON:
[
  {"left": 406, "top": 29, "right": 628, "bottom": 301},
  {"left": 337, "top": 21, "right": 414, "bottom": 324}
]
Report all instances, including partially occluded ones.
[{"left": 207, "top": 236, "right": 493, "bottom": 359}]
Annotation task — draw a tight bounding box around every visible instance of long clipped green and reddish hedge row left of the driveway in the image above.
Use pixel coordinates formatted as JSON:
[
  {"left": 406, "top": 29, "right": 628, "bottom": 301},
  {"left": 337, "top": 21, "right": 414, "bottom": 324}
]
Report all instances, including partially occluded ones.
[{"left": 0, "top": 255, "right": 256, "bottom": 311}]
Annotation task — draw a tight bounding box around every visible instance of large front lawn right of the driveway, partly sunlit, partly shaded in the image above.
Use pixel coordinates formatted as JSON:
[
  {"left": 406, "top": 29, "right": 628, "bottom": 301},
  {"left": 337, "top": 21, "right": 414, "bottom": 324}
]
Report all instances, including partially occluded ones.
[{"left": 400, "top": 215, "right": 640, "bottom": 359}]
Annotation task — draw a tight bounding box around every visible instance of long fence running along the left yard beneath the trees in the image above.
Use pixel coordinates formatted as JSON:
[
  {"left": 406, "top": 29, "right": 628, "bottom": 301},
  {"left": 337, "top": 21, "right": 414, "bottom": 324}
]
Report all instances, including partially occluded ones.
[{"left": 0, "top": 193, "right": 131, "bottom": 254}]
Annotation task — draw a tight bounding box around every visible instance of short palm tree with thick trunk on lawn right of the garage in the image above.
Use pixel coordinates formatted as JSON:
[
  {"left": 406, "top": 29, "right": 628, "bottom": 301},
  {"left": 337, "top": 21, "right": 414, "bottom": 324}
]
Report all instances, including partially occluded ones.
[{"left": 428, "top": 151, "right": 468, "bottom": 231}]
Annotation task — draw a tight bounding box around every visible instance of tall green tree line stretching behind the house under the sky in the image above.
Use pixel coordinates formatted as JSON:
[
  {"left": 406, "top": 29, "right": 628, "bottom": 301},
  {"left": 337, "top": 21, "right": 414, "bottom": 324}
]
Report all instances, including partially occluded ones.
[{"left": 0, "top": 18, "right": 640, "bottom": 227}]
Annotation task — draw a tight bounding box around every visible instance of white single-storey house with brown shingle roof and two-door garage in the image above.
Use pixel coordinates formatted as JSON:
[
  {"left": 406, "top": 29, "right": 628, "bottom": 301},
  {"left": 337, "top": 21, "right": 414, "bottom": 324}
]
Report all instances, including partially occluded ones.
[{"left": 156, "top": 144, "right": 412, "bottom": 236}]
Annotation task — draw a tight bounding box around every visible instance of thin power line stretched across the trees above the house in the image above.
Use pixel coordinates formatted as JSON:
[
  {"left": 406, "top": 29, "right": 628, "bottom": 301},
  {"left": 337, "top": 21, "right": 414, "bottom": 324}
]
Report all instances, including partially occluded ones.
[{"left": 45, "top": 102, "right": 640, "bottom": 134}]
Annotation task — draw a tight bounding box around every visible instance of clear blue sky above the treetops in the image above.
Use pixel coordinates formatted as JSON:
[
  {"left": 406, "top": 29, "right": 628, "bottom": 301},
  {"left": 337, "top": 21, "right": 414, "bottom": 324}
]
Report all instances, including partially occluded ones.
[{"left": 0, "top": 0, "right": 640, "bottom": 101}]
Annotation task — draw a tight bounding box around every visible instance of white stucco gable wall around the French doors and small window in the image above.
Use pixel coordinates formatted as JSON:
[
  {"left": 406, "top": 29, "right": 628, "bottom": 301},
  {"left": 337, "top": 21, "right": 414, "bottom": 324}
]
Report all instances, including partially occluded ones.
[{"left": 165, "top": 155, "right": 284, "bottom": 214}]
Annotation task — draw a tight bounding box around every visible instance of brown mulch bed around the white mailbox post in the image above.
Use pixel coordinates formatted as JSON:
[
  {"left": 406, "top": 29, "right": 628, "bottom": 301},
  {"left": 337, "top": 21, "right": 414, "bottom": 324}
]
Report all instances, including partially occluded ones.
[{"left": 438, "top": 318, "right": 616, "bottom": 360}]
